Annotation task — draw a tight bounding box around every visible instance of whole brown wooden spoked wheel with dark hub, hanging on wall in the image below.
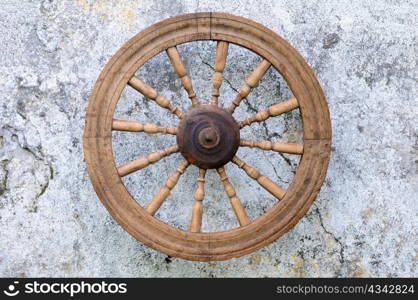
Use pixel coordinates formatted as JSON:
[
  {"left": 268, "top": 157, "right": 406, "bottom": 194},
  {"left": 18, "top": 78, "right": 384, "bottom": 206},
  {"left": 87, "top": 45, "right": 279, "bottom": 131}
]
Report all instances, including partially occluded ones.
[{"left": 83, "top": 13, "right": 331, "bottom": 261}]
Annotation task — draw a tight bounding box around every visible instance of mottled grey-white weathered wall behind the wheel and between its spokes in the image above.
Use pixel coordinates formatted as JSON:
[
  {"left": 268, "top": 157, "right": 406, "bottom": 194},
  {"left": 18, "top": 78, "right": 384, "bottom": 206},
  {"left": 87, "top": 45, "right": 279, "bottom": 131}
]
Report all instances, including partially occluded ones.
[{"left": 0, "top": 0, "right": 418, "bottom": 277}]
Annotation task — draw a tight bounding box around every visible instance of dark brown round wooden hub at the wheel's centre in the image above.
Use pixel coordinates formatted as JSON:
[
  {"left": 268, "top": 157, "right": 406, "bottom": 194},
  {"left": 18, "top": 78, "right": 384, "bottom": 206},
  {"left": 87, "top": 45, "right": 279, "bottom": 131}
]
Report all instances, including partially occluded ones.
[{"left": 177, "top": 105, "right": 240, "bottom": 169}]
